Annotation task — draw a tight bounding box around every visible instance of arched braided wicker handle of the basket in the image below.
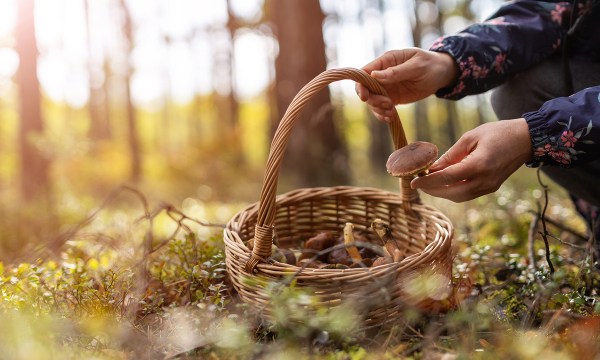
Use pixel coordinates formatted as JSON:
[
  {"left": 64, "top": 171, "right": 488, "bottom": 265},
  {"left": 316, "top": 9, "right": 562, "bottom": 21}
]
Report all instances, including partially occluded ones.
[{"left": 246, "top": 68, "right": 419, "bottom": 273}]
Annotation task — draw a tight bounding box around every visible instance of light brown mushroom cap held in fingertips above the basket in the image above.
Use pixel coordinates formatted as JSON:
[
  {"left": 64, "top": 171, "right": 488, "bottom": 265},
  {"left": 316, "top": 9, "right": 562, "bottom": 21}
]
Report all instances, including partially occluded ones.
[{"left": 386, "top": 141, "right": 438, "bottom": 177}]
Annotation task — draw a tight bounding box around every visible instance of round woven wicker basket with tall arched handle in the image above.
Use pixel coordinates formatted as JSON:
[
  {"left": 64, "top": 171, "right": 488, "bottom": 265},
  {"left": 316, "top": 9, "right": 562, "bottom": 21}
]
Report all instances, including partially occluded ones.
[{"left": 224, "top": 68, "right": 453, "bottom": 326}]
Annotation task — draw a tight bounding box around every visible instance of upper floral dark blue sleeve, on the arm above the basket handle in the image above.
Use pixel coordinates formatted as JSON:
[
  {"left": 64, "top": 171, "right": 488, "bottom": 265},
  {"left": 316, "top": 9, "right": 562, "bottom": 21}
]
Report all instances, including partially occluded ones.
[{"left": 430, "top": 0, "right": 571, "bottom": 100}]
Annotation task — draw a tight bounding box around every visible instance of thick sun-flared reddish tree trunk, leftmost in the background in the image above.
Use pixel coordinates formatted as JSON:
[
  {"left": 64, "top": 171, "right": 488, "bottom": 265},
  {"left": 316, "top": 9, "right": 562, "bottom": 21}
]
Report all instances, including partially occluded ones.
[{"left": 16, "top": 0, "right": 50, "bottom": 200}]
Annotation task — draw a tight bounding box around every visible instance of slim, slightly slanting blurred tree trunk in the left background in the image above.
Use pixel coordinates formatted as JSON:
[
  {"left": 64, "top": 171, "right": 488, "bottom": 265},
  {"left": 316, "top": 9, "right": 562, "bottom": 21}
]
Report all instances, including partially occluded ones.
[{"left": 119, "top": 0, "right": 142, "bottom": 184}]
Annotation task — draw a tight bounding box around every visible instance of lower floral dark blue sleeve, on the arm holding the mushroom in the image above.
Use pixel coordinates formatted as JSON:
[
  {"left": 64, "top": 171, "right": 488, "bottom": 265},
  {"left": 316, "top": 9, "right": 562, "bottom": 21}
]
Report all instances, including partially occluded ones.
[{"left": 523, "top": 86, "right": 600, "bottom": 167}]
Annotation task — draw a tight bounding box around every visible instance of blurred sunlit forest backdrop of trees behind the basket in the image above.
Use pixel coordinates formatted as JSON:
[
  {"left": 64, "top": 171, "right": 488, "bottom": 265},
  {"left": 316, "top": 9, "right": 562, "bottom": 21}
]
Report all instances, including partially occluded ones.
[{"left": 0, "top": 0, "right": 499, "bottom": 258}]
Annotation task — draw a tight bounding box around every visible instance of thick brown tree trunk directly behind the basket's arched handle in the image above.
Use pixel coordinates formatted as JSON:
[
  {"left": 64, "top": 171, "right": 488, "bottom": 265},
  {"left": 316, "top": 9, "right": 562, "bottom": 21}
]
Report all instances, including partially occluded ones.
[{"left": 270, "top": 0, "right": 349, "bottom": 186}]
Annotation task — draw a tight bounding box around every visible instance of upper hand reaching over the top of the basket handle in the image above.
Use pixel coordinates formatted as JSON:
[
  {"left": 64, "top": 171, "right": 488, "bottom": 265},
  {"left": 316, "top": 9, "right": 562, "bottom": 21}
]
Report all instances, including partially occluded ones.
[{"left": 356, "top": 48, "right": 458, "bottom": 121}]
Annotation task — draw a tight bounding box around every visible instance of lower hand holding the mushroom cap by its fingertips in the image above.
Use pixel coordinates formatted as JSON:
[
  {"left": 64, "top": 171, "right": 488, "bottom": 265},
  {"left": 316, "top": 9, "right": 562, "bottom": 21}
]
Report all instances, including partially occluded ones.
[{"left": 411, "top": 118, "right": 532, "bottom": 202}]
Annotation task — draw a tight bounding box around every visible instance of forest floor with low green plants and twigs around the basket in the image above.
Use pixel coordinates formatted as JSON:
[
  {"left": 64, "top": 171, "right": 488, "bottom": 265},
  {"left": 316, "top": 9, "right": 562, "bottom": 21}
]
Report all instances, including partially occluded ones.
[{"left": 0, "top": 170, "right": 600, "bottom": 359}]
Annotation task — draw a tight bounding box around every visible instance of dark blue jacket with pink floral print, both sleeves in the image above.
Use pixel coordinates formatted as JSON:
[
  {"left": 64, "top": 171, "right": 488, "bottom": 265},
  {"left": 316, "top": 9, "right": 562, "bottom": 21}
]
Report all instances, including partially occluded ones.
[{"left": 431, "top": 0, "right": 600, "bottom": 166}]
